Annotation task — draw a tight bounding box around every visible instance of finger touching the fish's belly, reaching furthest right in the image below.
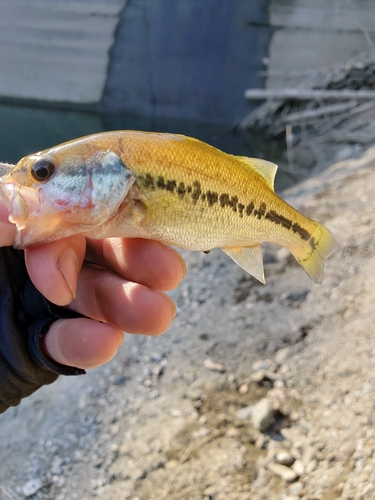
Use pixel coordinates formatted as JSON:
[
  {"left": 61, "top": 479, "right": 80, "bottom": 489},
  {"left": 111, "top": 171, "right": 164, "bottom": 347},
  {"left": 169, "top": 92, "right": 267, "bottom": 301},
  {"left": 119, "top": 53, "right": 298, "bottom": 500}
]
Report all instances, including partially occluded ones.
[{"left": 87, "top": 238, "right": 186, "bottom": 290}]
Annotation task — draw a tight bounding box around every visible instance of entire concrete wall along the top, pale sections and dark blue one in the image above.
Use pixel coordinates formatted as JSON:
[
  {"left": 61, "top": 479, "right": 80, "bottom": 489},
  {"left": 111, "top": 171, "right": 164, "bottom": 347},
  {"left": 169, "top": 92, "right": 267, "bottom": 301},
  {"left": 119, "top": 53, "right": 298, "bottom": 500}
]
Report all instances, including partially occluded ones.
[{"left": 0, "top": 0, "right": 375, "bottom": 123}]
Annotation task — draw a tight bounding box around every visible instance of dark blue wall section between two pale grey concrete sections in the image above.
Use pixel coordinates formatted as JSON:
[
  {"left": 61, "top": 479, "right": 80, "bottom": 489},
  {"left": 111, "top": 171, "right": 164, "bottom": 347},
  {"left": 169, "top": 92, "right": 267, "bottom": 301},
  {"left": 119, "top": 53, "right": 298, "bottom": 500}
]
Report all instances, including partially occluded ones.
[{"left": 101, "top": 0, "right": 271, "bottom": 123}]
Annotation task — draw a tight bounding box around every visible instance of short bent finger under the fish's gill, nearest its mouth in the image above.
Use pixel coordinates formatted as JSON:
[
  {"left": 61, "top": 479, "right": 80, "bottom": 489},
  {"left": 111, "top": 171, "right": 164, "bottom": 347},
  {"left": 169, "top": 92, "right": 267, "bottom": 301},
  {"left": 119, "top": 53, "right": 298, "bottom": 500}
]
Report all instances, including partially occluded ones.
[{"left": 25, "top": 236, "right": 86, "bottom": 306}]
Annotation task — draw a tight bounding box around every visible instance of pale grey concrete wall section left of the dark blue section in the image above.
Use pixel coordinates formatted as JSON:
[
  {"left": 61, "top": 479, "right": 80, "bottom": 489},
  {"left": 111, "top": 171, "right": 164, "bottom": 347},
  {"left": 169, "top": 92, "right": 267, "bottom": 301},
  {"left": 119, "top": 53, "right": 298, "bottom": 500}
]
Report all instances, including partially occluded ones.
[{"left": 0, "top": 0, "right": 126, "bottom": 104}]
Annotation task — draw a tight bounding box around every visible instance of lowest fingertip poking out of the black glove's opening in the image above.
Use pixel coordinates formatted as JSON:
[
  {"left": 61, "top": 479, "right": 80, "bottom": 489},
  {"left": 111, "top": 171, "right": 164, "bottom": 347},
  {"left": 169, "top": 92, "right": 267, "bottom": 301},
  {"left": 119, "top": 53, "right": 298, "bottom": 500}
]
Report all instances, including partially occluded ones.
[{"left": 43, "top": 318, "right": 124, "bottom": 369}]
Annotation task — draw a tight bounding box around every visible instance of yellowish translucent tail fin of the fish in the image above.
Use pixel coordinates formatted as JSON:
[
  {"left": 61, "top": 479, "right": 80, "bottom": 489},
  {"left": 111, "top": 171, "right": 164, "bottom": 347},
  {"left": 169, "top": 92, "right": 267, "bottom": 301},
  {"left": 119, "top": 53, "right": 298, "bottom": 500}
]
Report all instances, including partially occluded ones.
[{"left": 292, "top": 221, "right": 337, "bottom": 283}]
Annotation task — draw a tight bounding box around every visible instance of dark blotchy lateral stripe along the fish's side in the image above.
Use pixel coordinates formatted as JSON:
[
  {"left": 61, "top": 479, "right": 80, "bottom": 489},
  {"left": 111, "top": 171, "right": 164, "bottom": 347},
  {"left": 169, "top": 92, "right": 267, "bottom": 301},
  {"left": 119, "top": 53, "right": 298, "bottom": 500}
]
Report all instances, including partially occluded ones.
[{"left": 137, "top": 173, "right": 315, "bottom": 241}]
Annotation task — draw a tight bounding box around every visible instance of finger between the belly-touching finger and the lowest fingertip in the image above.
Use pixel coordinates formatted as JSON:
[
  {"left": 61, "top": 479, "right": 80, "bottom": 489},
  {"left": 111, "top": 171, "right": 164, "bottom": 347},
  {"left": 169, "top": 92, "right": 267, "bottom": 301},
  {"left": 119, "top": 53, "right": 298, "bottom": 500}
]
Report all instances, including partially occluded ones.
[{"left": 68, "top": 264, "right": 176, "bottom": 335}]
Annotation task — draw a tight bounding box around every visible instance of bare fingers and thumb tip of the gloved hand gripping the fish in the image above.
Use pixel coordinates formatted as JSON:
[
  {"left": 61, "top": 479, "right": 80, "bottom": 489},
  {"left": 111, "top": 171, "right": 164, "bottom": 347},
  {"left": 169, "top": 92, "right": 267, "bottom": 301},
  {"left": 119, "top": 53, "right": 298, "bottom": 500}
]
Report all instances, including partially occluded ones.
[{"left": 0, "top": 202, "right": 186, "bottom": 369}]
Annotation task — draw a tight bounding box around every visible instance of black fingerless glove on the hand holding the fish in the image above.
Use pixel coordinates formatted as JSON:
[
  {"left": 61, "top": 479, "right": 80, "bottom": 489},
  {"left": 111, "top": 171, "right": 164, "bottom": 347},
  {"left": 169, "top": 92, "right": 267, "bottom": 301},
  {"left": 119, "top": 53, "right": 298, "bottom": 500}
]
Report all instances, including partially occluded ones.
[{"left": 0, "top": 247, "right": 85, "bottom": 413}]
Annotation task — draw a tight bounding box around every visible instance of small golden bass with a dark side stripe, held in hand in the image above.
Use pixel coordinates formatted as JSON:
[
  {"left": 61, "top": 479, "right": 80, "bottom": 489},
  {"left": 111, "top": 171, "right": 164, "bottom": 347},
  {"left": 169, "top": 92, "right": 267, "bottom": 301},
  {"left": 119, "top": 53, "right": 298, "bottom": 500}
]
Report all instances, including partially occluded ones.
[{"left": 0, "top": 130, "right": 336, "bottom": 283}]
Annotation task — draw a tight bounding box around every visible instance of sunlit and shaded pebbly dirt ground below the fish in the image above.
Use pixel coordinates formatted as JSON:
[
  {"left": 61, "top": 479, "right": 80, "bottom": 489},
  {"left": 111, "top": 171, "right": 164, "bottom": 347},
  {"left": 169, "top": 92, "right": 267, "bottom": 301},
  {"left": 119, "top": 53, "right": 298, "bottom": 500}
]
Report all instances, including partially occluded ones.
[{"left": 0, "top": 142, "right": 375, "bottom": 500}]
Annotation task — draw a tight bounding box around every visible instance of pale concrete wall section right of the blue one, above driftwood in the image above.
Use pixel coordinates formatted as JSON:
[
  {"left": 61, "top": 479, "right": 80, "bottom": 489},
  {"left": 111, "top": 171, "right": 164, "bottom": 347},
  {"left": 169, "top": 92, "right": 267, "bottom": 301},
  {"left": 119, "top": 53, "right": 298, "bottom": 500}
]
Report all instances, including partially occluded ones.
[{"left": 266, "top": 0, "right": 375, "bottom": 88}]
